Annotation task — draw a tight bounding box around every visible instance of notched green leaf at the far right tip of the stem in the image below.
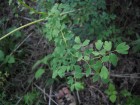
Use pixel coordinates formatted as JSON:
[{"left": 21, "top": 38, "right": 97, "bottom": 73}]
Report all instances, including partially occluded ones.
[{"left": 116, "top": 42, "right": 129, "bottom": 54}]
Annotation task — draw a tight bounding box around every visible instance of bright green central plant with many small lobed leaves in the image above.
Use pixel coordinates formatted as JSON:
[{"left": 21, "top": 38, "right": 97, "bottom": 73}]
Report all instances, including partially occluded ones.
[{"left": 34, "top": 4, "right": 129, "bottom": 95}]
